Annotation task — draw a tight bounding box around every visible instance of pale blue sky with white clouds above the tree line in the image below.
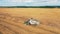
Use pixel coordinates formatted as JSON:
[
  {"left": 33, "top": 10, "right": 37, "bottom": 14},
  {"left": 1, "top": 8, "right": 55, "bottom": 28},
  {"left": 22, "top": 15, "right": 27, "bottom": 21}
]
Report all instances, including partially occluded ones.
[{"left": 0, "top": 0, "right": 60, "bottom": 6}]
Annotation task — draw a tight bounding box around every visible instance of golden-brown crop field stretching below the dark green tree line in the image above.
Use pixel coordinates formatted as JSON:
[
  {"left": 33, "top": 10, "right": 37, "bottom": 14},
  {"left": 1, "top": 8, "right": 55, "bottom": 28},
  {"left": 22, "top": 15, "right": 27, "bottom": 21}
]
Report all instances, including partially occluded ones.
[{"left": 0, "top": 8, "right": 60, "bottom": 34}]
